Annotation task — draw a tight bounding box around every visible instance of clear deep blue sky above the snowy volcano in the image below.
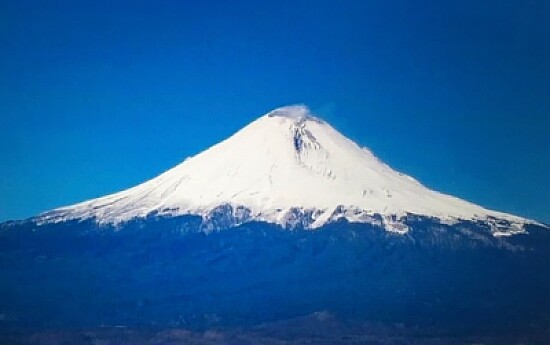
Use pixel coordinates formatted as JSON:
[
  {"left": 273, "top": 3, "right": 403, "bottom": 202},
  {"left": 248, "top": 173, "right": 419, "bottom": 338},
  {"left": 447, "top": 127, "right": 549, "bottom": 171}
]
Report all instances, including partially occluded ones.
[{"left": 0, "top": 0, "right": 550, "bottom": 223}]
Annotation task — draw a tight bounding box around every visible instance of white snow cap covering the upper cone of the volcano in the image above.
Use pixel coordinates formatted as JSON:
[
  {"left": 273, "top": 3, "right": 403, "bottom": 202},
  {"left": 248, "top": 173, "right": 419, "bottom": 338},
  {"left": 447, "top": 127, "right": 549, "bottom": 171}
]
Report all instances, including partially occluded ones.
[{"left": 37, "top": 105, "right": 534, "bottom": 236}]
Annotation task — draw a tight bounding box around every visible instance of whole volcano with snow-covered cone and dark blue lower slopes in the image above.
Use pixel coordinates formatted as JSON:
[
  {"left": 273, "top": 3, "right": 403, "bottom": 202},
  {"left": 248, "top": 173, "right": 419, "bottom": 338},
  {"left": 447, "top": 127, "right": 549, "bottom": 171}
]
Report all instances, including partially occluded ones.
[{"left": 0, "top": 105, "right": 550, "bottom": 344}]
